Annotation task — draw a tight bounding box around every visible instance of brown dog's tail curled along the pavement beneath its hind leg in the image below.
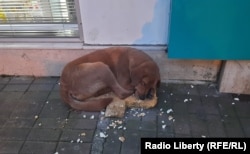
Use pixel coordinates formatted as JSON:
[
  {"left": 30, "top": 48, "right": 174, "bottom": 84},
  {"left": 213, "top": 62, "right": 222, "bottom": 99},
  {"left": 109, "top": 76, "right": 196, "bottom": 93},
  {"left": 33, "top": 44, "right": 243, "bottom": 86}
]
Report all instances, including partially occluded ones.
[{"left": 60, "top": 85, "right": 113, "bottom": 111}]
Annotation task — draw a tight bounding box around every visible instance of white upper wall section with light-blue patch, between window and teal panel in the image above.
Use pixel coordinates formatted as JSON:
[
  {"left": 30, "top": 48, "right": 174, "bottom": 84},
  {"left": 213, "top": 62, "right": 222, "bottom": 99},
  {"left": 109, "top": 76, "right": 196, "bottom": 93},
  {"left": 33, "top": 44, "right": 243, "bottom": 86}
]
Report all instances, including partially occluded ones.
[{"left": 80, "top": 0, "right": 170, "bottom": 45}]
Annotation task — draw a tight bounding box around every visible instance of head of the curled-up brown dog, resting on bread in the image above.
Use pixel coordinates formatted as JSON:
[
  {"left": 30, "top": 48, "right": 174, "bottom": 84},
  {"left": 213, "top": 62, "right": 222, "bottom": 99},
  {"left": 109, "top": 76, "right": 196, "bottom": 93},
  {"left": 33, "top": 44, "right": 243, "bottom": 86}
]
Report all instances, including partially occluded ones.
[{"left": 131, "top": 62, "right": 160, "bottom": 100}]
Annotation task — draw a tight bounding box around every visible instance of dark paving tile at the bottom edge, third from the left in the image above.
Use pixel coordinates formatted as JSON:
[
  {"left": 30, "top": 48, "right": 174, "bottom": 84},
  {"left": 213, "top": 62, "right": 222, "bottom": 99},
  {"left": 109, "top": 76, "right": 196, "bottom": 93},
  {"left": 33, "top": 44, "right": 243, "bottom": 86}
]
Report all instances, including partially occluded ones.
[{"left": 56, "top": 142, "right": 91, "bottom": 154}]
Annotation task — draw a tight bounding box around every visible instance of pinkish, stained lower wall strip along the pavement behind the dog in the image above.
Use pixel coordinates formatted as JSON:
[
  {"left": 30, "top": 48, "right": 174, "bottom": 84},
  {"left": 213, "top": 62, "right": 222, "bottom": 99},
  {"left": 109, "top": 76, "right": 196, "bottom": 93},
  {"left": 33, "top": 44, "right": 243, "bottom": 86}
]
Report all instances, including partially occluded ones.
[{"left": 0, "top": 49, "right": 221, "bottom": 82}]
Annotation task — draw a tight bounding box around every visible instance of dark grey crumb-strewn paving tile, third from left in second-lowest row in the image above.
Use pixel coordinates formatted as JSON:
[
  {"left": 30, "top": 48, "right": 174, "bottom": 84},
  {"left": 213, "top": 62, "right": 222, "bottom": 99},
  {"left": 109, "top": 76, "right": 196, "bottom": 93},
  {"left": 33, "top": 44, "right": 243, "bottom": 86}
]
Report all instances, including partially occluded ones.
[{"left": 60, "top": 129, "right": 94, "bottom": 143}]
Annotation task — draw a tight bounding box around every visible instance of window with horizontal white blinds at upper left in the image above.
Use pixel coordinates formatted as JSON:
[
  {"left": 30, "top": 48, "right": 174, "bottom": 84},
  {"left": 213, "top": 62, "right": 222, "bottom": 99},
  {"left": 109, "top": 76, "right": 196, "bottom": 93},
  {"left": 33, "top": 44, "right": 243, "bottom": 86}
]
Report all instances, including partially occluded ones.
[{"left": 0, "top": 0, "right": 79, "bottom": 38}]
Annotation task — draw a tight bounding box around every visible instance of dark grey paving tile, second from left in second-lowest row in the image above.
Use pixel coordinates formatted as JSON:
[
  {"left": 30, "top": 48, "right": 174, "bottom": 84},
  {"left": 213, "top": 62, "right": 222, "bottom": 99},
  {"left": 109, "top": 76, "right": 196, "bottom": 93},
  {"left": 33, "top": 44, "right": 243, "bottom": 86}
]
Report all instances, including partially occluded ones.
[{"left": 27, "top": 128, "right": 61, "bottom": 142}]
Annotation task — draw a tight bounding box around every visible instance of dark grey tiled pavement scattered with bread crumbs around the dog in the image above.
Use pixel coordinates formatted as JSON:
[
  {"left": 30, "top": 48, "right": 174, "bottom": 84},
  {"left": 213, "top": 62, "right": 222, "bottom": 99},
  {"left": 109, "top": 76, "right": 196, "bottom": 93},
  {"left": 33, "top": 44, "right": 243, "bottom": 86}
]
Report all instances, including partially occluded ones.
[{"left": 0, "top": 77, "right": 250, "bottom": 154}]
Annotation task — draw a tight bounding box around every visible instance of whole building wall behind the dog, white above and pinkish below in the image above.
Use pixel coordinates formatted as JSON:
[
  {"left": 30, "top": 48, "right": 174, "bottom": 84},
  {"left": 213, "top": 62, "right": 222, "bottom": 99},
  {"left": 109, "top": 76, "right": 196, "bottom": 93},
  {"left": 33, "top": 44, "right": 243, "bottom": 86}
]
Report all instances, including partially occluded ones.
[{"left": 0, "top": 0, "right": 250, "bottom": 94}]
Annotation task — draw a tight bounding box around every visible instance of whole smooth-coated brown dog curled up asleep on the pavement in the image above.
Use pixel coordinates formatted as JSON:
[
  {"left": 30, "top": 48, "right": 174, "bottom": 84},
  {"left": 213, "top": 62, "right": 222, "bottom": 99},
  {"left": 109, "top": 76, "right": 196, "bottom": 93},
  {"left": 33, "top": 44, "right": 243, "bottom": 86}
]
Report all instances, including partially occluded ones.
[{"left": 60, "top": 47, "right": 160, "bottom": 111}]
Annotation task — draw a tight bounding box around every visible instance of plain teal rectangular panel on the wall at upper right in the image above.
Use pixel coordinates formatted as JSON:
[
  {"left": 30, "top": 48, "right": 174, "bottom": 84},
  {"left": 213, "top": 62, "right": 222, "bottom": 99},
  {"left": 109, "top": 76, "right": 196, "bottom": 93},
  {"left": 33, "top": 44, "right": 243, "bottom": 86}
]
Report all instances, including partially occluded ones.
[{"left": 168, "top": 0, "right": 250, "bottom": 60}]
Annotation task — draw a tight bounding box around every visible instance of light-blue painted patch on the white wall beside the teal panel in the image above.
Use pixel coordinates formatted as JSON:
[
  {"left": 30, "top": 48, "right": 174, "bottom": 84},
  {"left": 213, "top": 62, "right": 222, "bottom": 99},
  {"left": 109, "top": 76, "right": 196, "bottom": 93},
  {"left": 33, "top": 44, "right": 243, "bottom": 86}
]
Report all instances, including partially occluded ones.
[{"left": 134, "top": 0, "right": 169, "bottom": 45}]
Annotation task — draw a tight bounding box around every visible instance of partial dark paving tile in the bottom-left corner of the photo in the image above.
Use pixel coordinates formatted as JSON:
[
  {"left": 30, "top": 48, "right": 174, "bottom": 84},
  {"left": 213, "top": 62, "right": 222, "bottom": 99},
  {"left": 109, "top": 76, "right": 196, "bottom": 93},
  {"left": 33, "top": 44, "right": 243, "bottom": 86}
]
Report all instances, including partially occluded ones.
[{"left": 0, "top": 141, "right": 24, "bottom": 154}]
